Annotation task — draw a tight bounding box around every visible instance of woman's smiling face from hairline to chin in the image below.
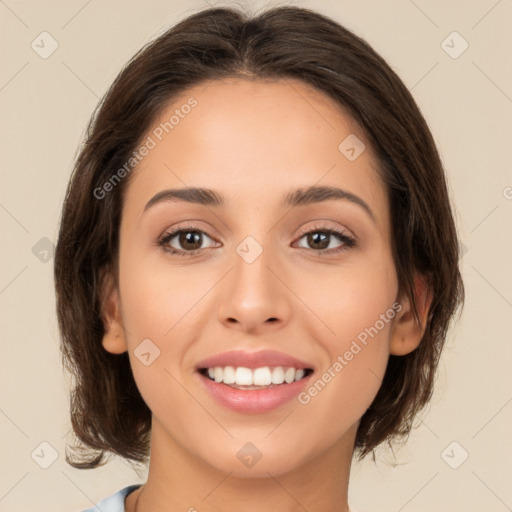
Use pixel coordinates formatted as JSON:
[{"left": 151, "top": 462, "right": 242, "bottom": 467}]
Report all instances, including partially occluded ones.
[{"left": 104, "top": 79, "right": 406, "bottom": 476}]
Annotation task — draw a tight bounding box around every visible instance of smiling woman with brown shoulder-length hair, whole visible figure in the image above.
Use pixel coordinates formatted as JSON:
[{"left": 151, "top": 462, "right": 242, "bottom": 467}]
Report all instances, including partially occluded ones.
[{"left": 55, "top": 7, "right": 463, "bottom": 512}]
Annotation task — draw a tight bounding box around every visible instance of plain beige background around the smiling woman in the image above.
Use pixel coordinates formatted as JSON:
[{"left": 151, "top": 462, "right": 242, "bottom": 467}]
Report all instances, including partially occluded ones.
[{"left": 0, "top": 0, "right": 512, "bottom": 512}]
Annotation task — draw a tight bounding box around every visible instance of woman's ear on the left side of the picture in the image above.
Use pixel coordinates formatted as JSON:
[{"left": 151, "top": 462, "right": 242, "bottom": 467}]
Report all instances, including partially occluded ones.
[{"left": 100, "top": 270, "right": 128, "bottom": 354}]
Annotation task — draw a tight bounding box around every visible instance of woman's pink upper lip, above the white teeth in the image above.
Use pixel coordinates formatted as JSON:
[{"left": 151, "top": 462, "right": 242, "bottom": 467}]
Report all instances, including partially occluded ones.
[{"left": 196, "top": 350, "right": 313, "bottom": 370}]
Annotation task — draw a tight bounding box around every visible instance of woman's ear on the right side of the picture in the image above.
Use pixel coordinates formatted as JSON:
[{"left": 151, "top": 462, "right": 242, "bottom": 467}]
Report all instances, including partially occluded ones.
[{"left": 389, "top": 276, "right": 432, "bottom": 356}]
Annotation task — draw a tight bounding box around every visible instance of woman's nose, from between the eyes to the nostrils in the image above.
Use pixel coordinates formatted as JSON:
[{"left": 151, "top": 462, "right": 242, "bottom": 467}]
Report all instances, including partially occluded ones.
[{"left": 218, "top": 242, "right": 293, "bottom": 334}]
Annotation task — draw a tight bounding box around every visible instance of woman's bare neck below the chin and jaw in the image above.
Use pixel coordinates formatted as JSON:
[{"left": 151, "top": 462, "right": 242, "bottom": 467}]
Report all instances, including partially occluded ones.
[{"left": 125, "top": 418, "right": 355, "bottom": 512}]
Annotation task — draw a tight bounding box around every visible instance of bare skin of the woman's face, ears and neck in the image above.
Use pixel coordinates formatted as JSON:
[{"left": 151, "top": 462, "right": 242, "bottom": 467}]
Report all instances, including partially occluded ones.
[{"left": 103, "top": 79, "right": 428, "bottom": 512}]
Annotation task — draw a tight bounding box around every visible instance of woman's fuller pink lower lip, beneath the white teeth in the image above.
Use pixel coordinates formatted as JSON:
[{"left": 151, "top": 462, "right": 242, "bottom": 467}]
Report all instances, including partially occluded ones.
[{"left": 198, "top": 372, "right": 312, "bottom": 414}]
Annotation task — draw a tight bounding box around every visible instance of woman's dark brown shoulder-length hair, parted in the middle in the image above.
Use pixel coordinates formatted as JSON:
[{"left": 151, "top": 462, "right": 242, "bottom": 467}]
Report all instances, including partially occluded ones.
[{"left": 55, "top": 7, "right": 464, "bottom": 468}]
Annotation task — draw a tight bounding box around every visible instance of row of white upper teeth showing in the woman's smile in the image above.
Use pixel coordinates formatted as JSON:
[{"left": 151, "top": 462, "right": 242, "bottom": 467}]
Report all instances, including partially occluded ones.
[{"left": 203, "top": 366, "right": 306, "bottom": 386}]
